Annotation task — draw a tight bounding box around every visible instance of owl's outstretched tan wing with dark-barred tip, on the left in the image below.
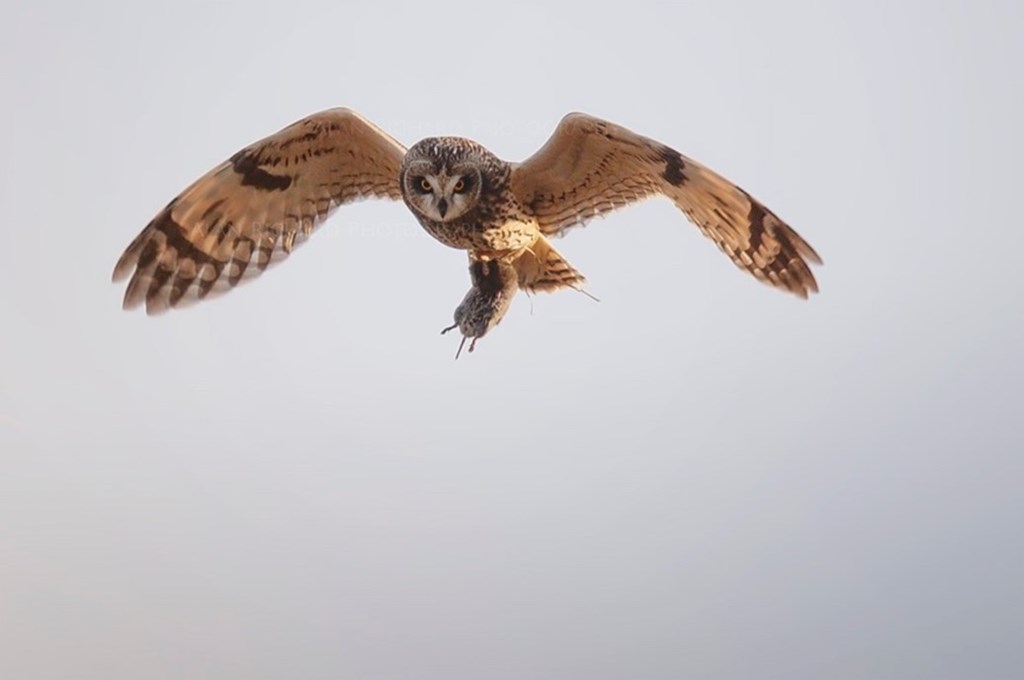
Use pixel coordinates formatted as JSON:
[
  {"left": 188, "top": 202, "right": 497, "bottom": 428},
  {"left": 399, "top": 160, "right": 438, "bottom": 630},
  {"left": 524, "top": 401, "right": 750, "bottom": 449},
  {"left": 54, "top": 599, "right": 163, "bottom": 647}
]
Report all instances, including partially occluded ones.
[{"left": 114, "top": 109, "right": 406, "bottom": 314}]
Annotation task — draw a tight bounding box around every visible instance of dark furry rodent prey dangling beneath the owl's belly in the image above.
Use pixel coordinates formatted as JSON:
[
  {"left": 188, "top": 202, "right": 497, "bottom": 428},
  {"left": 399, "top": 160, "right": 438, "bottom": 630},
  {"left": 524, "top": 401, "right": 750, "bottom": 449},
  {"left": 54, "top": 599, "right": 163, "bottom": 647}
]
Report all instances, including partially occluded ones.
[{"left": 441, "top": 260, "right": 519, "bottom": 358}]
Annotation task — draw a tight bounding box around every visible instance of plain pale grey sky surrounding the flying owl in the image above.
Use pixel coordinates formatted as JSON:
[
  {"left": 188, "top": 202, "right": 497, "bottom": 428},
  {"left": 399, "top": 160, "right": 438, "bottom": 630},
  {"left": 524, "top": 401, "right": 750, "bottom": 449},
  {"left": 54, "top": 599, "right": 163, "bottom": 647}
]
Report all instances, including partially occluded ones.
[{"left": 0, "top": 1, "right": 1024, "bottom": 680}]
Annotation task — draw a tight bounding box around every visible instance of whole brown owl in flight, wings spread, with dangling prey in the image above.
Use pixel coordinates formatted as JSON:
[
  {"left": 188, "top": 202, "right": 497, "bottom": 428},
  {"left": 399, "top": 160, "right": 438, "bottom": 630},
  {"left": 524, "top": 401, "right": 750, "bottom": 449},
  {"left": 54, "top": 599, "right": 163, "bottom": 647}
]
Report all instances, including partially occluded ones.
[{"left": 114, "top": 109, "right": 821, "bottom": 350}]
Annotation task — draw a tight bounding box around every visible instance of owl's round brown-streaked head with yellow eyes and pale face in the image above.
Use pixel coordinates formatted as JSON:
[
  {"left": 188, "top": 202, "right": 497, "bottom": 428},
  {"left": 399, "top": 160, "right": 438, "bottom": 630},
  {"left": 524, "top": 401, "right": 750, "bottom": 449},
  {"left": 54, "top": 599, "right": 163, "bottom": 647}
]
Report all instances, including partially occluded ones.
[{"left": 400, "top": 137, "right": 501, "bottom": 222}]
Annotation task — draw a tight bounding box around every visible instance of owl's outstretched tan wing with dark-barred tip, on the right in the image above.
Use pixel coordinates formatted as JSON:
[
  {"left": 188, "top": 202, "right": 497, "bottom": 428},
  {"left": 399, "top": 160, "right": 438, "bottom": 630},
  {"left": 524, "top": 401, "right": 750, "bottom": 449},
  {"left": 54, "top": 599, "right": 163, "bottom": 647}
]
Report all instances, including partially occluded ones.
[{"left": 512, "top": 114, "right": 821, "bottom": 298}]
